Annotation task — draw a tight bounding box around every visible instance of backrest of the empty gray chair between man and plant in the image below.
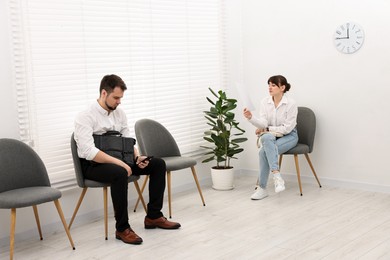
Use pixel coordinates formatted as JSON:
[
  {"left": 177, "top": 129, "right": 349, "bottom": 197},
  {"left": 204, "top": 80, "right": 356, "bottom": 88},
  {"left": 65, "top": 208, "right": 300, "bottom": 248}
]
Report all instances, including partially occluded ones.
[{"left": 134, "top": 119, "right": 181, "bottom": 158}]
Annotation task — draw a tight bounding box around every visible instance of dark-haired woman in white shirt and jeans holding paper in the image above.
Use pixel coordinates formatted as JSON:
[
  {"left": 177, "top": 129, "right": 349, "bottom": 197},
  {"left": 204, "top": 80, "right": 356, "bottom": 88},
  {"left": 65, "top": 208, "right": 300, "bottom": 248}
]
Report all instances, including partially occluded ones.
[{"left": 244, "top": 75, "right": 298, "bottom": 200}]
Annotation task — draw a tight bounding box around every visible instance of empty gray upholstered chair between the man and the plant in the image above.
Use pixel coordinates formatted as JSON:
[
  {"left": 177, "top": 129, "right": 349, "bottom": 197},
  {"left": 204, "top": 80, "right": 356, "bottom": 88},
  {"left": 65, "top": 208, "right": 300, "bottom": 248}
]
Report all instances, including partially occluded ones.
[{"left": 134, "top": 119, "right": 206, "bottom": 218}]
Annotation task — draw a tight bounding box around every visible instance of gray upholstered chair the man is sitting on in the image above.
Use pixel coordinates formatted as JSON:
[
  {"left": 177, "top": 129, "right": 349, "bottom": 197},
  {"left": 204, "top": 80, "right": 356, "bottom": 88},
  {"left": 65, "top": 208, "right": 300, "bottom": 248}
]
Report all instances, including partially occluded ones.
[{"left": 69, "top": 134, "right": 146, "bottom": 240}]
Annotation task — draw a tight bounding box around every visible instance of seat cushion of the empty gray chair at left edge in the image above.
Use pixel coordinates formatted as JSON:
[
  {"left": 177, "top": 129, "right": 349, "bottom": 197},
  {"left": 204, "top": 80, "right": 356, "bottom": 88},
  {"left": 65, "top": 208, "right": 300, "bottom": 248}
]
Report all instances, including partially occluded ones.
[{"left": 0, "top": 186, "right": 62, "bottom": 209}]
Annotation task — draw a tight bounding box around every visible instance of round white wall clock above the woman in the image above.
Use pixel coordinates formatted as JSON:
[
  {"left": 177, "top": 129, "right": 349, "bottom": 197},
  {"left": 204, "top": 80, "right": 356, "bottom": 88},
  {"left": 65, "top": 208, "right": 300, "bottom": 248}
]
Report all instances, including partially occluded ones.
[{"left": 333, "top": 22, "right": 364, "bottom": 54}]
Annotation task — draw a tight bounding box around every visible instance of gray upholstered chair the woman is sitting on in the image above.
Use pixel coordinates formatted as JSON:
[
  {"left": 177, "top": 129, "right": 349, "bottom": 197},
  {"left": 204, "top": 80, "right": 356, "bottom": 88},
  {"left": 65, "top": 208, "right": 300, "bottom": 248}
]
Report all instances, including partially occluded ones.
[{"left": 279, "top": 107, "right": 322, "bottom": 196}]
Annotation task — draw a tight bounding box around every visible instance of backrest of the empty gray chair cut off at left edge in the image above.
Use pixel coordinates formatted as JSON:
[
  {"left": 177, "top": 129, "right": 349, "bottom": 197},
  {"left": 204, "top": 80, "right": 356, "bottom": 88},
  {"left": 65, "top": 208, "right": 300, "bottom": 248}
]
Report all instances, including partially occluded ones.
[{"left": 0, "top": 138, "right": 50, "bottom": 192}]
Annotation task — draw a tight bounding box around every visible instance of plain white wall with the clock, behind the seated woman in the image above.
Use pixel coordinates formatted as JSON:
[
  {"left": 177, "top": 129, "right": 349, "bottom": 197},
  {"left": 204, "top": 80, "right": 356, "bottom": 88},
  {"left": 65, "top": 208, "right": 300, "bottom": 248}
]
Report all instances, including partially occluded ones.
[{"left": 228, "top": 0, "right": 390, "bottom": 191}]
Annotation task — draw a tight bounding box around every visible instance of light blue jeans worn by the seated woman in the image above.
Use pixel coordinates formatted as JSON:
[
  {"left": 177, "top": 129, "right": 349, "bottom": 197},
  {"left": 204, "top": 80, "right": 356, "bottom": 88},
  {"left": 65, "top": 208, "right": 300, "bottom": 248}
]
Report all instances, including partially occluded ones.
[{"left": 259, "top": 128, "right": 298, "bottom": 189}]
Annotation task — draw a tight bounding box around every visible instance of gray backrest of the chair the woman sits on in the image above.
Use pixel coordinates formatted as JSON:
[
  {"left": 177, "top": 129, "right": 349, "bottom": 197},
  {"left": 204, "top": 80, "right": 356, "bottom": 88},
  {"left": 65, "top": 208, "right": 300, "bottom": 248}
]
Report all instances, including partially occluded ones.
[{"left": 297, "top": 107, "right": 316, "bottom": 153}]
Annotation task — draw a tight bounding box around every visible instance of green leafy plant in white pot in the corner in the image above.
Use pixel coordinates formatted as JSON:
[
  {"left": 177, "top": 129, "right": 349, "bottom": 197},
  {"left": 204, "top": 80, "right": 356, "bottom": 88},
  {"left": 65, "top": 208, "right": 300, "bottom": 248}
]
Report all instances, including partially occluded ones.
[{"left": 201, "top": 88, "right": 248, "bottom": 190}]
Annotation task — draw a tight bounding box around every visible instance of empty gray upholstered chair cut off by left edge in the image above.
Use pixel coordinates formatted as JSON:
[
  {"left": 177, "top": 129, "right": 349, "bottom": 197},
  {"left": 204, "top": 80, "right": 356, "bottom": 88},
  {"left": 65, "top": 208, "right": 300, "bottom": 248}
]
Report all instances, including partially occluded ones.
[{"left": 0, "top": 138, "right": 75, "bottom": 259}]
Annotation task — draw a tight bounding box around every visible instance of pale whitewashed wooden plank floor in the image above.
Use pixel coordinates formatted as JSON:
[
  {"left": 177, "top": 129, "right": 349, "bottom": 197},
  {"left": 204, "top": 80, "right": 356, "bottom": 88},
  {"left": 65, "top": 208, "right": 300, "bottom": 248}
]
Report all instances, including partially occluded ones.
[{"left": 0, "top": 176, "right": 390, "bottom": 260}]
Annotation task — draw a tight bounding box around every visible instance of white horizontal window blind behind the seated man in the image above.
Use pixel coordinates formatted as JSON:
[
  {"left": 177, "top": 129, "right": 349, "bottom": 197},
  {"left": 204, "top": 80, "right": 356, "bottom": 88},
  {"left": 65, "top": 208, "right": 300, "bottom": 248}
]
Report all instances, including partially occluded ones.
[{"left": 9, "top": 0, "right": 226, "bottom": 189}]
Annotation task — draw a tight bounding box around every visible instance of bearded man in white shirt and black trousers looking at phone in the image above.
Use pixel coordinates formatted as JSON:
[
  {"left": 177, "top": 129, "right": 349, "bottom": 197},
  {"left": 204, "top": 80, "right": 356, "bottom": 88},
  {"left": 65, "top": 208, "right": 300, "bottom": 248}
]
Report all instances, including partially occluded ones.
[{"left": 74, "top": 75, "right": 180, "bottom": 244}]
